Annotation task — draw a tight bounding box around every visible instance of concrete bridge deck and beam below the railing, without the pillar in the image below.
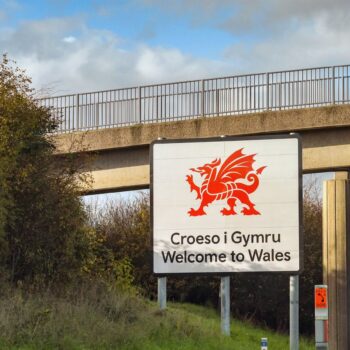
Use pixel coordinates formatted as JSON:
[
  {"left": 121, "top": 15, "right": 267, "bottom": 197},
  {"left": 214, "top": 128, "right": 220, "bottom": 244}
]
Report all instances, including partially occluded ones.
[{"left": 56, "top": 105, "right": 350, "bottom": 193}]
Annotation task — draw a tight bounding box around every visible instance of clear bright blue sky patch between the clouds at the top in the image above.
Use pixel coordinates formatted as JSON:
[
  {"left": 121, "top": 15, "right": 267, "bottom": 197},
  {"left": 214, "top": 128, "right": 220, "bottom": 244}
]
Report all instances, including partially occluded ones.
[{"left": 3, "top": 0, "right": 235, "bottom": 58}]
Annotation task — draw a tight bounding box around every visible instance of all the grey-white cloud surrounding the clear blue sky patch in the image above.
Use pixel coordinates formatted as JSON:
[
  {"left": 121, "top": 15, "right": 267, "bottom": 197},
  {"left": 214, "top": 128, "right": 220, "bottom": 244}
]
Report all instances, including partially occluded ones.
[{"left": 0, "top": 0, "right": 350, "bottom": 94}]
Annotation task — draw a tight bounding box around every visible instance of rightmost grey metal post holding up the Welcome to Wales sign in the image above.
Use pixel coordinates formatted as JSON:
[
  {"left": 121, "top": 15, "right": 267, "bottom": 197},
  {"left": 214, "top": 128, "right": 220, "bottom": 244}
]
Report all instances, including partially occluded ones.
[{"left": 289, "top": 276, "right": 299, "bottom": 350}]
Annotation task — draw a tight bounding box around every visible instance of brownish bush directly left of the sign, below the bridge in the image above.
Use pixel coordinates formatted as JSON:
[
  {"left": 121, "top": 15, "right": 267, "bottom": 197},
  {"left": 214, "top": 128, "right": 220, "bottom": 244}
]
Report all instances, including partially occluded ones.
[{"left": 88, "top": 193, "right": 156, "bottom": 298}]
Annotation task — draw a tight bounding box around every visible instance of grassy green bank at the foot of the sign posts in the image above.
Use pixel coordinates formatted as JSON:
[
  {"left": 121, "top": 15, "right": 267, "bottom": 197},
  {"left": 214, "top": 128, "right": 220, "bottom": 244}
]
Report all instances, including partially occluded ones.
[{"left": 0, "top": 288, "right": 314, "bottom": 350}]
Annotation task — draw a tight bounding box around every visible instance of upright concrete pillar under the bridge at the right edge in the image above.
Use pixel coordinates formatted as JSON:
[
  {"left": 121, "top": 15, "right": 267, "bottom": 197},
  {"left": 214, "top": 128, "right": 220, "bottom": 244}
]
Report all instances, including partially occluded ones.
[{"left": 323, "top": 172, "right": 350, "bottom": 350}]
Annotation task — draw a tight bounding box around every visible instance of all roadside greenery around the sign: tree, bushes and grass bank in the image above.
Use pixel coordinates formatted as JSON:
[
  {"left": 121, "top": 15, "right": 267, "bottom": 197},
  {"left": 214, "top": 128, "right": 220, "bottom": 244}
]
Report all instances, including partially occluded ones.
[{"left": 0, "top": 56, "right": 322, "bottom": 350}]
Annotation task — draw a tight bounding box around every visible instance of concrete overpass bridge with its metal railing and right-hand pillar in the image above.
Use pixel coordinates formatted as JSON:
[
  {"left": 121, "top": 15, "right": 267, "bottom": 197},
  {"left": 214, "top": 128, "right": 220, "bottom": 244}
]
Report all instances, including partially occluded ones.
[{"left": 44, "top": 65, "right": 350, "bottom": 350}]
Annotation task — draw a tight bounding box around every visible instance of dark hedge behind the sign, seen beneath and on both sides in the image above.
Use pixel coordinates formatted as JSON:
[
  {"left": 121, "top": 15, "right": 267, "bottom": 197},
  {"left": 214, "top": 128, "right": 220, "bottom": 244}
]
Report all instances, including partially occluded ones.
[{"left": 89, "top": 182, "right": 322, "bottom": 336}]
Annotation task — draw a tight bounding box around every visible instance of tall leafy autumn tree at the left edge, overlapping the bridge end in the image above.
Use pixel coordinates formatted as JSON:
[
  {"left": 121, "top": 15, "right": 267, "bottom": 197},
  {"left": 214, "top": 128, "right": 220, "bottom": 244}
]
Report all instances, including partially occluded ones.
[{"left": 0, "top": 55, "right": 89, "bottom": 284}]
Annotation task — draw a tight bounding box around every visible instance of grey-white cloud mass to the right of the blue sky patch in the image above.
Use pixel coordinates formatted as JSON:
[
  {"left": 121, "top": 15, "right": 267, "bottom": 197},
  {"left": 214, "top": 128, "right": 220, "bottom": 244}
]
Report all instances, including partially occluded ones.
[{"left": 137, "top": 0, "right": 350, "bottom": 73}]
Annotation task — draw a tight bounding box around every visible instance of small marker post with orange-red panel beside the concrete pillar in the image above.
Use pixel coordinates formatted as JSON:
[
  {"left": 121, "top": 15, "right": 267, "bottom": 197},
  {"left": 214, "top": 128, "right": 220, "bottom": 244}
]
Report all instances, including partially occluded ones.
[{"left": 315, "top": 285, "right": 328, "bottom": 350}]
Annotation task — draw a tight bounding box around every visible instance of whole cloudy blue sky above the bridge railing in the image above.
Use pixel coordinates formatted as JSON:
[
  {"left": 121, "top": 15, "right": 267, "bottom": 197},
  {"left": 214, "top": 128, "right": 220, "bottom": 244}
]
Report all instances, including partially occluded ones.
[{"left": 0, "top": 0, "right": 344, "bottom": 204}]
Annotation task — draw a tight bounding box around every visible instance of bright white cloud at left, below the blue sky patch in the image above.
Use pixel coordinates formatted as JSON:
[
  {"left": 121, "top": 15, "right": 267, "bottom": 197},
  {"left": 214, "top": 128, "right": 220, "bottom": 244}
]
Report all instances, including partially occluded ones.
[{"left": 0, "top": 18, "right": 229, "bottom": 95}]
